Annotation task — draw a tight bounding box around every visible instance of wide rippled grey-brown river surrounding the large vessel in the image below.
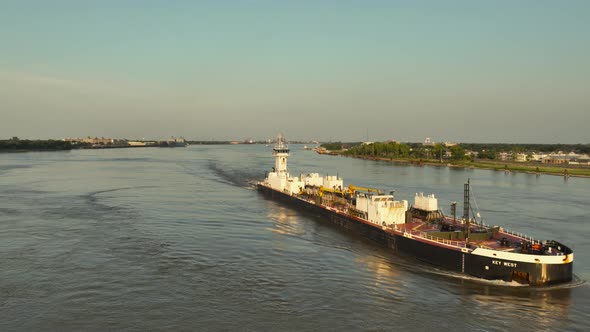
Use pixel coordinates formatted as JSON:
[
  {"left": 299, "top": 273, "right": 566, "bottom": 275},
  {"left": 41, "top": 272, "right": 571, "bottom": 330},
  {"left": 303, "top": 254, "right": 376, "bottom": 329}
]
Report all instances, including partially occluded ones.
[{"left": 0, "top": 145, "right": 590, "bottom": 331}]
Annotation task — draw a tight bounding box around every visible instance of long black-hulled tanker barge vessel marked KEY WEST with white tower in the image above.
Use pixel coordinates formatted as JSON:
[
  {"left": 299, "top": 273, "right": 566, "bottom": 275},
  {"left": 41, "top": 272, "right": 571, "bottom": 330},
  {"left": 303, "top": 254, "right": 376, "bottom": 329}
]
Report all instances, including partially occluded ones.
[{"left": 256, "top": 136, "right": 574, "bottom": 286}]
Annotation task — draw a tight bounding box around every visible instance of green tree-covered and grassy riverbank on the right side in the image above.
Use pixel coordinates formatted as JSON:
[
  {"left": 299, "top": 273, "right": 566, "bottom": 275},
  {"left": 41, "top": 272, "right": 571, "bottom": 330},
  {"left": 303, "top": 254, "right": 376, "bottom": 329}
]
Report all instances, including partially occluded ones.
[{"left": 316, "top": 142, "right": 590, "bottom": 178}]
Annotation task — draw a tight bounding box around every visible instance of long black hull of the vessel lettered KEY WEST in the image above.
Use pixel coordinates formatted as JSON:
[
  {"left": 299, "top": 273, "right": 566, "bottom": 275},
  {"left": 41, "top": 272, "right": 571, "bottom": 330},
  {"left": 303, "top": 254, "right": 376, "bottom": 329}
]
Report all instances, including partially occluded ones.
[{"left": 257, "top": 185, "right": 573, "bottom": 286}]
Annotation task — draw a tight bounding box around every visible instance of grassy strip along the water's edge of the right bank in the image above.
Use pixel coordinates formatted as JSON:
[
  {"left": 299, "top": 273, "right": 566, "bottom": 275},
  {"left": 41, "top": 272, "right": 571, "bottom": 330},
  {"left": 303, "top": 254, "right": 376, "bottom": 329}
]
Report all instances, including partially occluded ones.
[{"left": 339, "top": 154, "right": 590, "bottom": 177}]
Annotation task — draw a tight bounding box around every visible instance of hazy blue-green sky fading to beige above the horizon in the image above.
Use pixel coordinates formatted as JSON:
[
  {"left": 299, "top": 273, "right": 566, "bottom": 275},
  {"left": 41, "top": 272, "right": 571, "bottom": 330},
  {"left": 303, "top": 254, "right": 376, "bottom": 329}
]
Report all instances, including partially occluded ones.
[{"left": 0, "top": 0, "right": 590, "bottom": 144}]
